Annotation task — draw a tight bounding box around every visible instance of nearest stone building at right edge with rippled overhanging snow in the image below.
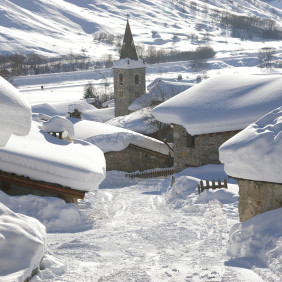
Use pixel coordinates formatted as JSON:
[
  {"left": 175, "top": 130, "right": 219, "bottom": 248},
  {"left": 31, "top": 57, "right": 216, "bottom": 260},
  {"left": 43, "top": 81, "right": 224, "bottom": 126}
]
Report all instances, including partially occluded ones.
[{"left": 219, "top": 107, "right": 282, "bottom": 221}]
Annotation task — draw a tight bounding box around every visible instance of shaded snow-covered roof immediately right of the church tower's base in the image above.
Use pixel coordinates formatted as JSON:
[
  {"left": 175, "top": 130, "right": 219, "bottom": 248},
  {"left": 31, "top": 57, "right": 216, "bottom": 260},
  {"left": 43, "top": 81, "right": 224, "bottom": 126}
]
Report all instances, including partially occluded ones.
[{"left": 128, "top": 79, "right": 194, "bottom": 111}]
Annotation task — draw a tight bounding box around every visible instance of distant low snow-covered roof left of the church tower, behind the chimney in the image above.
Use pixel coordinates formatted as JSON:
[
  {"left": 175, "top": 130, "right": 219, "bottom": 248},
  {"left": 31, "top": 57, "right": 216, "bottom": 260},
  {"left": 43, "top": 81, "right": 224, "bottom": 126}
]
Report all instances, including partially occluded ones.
[{"left": 32, "top": 100, "right": 95, "bottom": 116}]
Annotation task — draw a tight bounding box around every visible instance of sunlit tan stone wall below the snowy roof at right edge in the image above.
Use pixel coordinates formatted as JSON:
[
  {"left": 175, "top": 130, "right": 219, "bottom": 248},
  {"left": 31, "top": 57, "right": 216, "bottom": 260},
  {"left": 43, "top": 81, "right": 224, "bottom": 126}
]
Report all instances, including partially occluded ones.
[{"left": 237, "top": 179, "right": 282, "bottom": 222}]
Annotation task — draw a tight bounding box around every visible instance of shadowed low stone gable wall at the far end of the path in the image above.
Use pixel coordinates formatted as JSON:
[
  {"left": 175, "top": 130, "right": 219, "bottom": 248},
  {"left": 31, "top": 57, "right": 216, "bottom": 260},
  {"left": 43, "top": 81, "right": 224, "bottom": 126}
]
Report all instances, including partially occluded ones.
[{"left": 105, "top": 145, "right": 172, "bottom": 172}]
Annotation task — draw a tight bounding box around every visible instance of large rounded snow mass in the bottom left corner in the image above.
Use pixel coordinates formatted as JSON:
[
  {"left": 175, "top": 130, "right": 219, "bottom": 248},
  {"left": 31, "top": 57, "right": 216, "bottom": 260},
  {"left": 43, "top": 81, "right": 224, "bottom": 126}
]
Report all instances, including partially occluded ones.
[{"left": 0, "top": 202, "right": 46, "bottom": 282}]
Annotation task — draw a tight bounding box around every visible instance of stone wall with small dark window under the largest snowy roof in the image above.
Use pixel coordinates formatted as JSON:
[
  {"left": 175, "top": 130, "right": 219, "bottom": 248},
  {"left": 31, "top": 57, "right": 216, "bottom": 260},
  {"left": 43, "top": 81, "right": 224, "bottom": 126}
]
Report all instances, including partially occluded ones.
[{"left": 173, "top": 125, "right": 239, "bottom": 171}]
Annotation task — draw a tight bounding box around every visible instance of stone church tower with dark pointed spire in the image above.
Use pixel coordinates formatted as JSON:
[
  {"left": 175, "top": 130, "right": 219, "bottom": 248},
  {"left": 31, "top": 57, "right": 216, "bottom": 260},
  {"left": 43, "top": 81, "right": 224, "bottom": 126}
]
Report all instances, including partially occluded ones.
[{"left": 113, "top": 20, "right": 146, "bottom": 117}]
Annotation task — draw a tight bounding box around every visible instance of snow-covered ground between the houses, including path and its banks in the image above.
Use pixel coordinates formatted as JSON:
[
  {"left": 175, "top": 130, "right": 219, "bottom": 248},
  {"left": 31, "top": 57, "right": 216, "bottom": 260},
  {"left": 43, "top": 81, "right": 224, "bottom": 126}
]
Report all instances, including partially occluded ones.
[{"left": 0, "top": 165, "right": 282, "bottom": 282}]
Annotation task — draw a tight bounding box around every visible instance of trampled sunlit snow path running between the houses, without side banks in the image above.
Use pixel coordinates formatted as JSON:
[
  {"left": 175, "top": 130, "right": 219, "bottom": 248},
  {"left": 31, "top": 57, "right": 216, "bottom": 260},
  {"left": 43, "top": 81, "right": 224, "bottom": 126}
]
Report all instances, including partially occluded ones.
[{"left": 34, "top": 177, "right": 262, "bottom": 281}]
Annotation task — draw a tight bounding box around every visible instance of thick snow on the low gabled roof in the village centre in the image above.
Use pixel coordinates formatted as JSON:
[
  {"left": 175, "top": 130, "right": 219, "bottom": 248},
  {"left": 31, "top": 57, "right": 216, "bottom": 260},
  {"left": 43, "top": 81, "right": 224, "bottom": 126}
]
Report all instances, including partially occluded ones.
[{"left": 70, "top": 119, "right": 169, "bottom": 155}]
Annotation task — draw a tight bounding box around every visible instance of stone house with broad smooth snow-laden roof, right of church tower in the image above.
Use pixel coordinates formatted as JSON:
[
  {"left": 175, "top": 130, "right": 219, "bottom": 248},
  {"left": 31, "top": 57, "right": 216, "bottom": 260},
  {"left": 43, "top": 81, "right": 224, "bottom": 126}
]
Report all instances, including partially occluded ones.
[{"left": 152, "top": 75, "right": 282, "bottom": 171}]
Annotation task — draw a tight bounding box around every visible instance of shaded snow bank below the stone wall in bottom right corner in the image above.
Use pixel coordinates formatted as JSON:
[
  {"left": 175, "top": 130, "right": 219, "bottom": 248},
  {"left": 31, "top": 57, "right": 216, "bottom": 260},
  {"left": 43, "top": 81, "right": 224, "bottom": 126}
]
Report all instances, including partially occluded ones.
[{"left": 227, "top": 209, "right": 282, "bottom": 281}]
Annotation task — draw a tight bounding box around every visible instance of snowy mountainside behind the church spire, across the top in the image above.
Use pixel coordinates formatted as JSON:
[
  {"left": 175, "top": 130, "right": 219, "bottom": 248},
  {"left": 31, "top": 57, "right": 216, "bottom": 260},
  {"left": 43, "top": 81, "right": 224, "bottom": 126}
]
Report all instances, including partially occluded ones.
[{"left": 0, "top": 0, "right": 282, "bottom": 58}]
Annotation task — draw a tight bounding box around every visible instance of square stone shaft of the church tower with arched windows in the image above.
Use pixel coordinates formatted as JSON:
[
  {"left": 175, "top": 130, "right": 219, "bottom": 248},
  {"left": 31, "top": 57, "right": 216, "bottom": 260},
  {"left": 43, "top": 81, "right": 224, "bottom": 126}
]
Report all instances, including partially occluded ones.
[{"left": 113, "top": 67, "right": 146, "bottom": 117}]
